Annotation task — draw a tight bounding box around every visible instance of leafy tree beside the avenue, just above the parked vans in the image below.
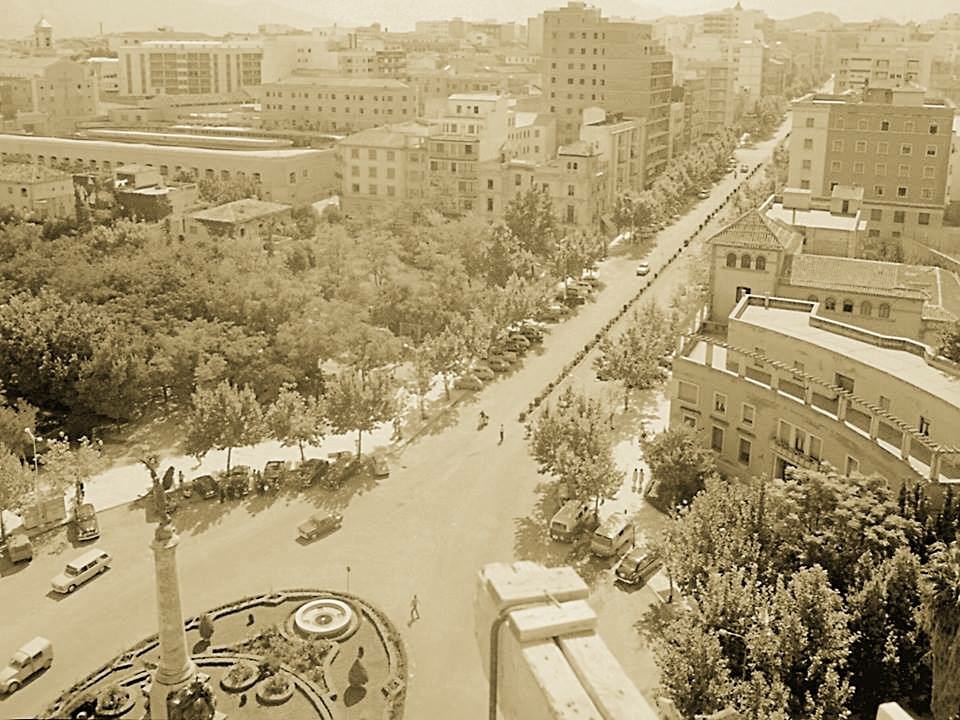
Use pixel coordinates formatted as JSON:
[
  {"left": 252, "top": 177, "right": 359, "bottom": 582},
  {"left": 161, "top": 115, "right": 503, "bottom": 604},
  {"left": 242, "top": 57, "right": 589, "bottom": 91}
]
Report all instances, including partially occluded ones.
[{"left": 531, "top": 387, "right": 623, "bottom": 512}]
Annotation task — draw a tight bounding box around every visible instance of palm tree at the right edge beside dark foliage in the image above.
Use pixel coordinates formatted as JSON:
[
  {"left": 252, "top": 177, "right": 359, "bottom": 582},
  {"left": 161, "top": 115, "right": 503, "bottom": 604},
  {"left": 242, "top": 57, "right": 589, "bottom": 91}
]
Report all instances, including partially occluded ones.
[{"left": 922, "top": 542, "right": 960, "bottom": 720}]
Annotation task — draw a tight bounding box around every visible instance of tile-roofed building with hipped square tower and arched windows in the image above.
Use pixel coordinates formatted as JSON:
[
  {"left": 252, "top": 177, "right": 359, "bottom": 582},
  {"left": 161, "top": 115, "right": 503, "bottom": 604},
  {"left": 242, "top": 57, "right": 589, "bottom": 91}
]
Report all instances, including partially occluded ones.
[{"left": 708, "top": 209, "right": 960, "bottom": 344}]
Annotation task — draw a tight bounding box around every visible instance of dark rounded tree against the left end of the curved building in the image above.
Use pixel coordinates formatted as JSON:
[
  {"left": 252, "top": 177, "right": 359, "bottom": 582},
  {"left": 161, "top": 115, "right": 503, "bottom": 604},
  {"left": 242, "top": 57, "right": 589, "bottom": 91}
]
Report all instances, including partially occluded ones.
[{"left": 643, "top": 425, "right": 718, "bottom": 509}]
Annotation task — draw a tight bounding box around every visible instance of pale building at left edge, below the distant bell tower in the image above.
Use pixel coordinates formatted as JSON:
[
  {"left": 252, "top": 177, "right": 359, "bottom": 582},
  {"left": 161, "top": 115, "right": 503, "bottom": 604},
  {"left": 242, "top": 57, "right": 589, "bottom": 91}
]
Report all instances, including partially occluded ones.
[{"left": 0, "top": 56, "right": 98, "bottom": 132}]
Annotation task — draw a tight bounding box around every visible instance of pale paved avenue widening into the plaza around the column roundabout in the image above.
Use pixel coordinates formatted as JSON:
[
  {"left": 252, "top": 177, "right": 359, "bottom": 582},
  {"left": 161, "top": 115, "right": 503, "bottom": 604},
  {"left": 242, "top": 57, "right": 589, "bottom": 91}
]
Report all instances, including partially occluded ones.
[{"left": 0, "top": 121, "right": 788, "bottom": 718}]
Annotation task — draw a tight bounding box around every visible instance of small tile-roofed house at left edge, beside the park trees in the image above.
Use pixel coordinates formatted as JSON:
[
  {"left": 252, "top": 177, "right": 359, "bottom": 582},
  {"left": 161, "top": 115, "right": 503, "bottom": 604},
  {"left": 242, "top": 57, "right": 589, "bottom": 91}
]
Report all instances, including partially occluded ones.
[{"left": 0, "top": 163, "right": 76, "bottom": 218}]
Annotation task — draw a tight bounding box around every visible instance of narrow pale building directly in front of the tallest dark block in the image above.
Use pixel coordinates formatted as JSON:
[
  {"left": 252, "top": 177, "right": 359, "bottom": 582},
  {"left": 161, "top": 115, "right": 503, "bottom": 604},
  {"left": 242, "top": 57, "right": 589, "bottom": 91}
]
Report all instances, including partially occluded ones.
[{"left": 580, "top": 108, "right": 646, "bottom": 208}]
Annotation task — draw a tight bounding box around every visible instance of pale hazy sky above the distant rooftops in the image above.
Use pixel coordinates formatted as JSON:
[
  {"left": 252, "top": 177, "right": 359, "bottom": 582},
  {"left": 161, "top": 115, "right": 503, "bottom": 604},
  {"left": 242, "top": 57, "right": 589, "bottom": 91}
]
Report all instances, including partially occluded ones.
[{"left": 7, "top": 0, "right": 955, "bottom": 38}]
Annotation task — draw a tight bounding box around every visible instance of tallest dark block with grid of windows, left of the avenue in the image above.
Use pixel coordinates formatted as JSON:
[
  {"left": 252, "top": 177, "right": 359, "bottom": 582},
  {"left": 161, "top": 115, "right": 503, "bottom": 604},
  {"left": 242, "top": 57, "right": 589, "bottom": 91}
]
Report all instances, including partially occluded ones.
[{"left": 541, "top": 0, "right": 673, "bottom": 181}]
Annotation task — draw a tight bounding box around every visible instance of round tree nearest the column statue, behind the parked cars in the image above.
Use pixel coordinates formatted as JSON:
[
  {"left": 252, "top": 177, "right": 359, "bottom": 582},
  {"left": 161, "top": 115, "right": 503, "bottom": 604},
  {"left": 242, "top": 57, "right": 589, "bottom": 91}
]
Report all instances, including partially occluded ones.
[{"left": 184, "top": 381, "right": 264, "bottom": 474}]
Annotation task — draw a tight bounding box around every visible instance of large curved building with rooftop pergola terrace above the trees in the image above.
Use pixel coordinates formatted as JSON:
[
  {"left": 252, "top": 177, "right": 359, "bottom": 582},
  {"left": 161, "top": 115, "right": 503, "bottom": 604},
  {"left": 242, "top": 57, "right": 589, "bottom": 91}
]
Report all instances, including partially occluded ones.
[{"left": 670, "top": 295, "right": 960, "bottom": 489}]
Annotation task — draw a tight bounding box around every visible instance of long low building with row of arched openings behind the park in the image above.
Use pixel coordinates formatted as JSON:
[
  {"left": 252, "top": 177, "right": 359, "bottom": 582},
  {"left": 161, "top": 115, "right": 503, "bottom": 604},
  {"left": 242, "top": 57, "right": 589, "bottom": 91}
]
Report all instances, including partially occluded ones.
[{"left": 0, "top": 134, "right": 337, "bottom": 205}]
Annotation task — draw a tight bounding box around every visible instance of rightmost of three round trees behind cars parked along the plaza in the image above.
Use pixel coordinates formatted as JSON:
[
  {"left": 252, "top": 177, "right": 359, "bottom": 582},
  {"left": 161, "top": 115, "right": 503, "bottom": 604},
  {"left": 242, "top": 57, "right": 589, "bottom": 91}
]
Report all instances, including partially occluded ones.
[{"left": 327, "top": 368, "right": 397, "bottom": 455}]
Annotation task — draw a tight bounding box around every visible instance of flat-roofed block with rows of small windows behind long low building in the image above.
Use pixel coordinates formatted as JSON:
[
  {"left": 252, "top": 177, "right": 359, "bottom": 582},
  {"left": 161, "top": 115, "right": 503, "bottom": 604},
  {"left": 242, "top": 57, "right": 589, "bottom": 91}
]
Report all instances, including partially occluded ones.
[{"left": 260, "top": 72, "right": 417, "bottom": 134}]
